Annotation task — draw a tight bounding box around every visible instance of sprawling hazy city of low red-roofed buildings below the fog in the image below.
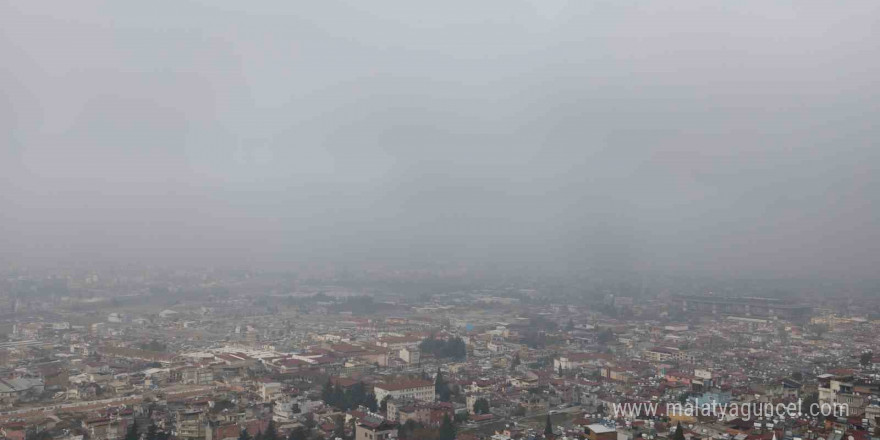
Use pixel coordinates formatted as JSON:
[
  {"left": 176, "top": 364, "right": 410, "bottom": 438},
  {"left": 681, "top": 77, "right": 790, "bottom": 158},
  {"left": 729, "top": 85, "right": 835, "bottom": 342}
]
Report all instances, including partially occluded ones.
[{"left": 0, "top": 272, "right": 880, "bottom": 440}]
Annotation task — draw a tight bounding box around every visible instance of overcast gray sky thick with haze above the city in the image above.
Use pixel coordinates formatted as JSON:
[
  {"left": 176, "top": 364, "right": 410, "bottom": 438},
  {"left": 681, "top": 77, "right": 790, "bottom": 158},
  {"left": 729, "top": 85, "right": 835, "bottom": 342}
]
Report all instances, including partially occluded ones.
[{"left": 0, "top": 0, "right": 880, "bottom": 277}]
